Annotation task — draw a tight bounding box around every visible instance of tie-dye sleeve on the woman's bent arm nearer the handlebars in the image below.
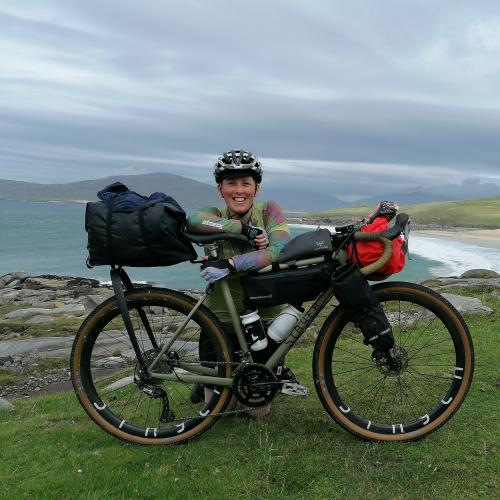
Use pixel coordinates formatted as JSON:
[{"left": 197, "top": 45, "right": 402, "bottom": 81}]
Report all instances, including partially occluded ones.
[{"left": 233, "top": 201, "right": 290, "bottom": 272}]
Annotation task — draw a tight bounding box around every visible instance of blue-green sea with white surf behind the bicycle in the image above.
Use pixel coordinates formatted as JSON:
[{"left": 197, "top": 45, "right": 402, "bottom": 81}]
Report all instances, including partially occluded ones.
[{"left": 0, "top": 201, "right": 500, "bottom": 290}]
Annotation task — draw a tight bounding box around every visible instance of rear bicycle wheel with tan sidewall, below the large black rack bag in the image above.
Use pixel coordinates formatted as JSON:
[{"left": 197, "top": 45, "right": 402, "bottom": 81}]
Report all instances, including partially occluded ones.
[{"left": 71, "top": 287, "right": 234, "bottom": 445}]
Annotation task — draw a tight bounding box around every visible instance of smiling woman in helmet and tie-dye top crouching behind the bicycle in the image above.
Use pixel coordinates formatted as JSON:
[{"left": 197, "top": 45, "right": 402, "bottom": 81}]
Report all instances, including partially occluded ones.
[{"left": 188, "top": 149, "right": 307, "bottom": 414}]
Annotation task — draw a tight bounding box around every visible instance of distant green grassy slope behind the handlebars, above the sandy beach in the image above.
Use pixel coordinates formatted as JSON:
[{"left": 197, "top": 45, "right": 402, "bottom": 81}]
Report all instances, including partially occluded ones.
[{"left": 304, "top": 196, "right": 500, "bottom": 229}]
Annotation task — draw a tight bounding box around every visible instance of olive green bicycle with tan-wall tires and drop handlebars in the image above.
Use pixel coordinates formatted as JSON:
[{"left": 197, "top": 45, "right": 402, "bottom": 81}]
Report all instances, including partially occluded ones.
[{"left": 71, "top": 214, "right": 474, "bottom": 445}]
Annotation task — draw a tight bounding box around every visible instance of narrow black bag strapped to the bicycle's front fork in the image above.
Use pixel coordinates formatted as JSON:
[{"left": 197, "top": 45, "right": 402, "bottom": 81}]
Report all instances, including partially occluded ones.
[{"left": 332, "top": 264, "right": 394, "bottom": 351}]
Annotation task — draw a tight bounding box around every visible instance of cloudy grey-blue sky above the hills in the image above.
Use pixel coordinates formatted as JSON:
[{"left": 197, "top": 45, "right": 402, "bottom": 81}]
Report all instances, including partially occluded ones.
[{"left": 0, "top": 0, "right": 500, "bottom": 198}]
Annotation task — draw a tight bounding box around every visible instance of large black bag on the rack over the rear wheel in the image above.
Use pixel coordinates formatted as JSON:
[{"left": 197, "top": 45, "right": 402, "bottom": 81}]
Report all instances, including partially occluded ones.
[{"left": 85, "top": 202, "right": 197, "bottom": 267}]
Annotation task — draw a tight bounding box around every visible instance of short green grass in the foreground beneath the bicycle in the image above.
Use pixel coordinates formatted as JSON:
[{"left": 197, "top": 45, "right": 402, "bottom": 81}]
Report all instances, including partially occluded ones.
[{"left": 0, "top": 292, "right": 500, "bottom": 499}]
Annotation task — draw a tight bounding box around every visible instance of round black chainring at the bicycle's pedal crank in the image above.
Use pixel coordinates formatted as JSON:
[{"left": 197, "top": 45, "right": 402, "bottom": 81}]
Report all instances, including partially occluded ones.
[{"left": 232, "top": 363, "right": 281, "bottom": 408}]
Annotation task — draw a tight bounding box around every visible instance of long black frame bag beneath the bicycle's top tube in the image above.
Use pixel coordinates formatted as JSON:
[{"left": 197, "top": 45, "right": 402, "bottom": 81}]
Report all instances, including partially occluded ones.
[{"left": 241, "top": 262, "right": 334, "bottom": 307}]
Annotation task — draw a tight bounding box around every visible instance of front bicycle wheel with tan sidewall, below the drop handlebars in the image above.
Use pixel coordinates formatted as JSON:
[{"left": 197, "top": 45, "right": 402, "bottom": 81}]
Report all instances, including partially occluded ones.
[{"left": 313, "top": 282, "right": 474, "bottom": 441}]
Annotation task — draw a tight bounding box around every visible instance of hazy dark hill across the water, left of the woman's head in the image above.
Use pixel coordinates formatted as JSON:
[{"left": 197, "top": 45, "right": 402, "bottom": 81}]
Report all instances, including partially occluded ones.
[{"left": 0, "top": 174, "right": 220, "bottom": 207}]
